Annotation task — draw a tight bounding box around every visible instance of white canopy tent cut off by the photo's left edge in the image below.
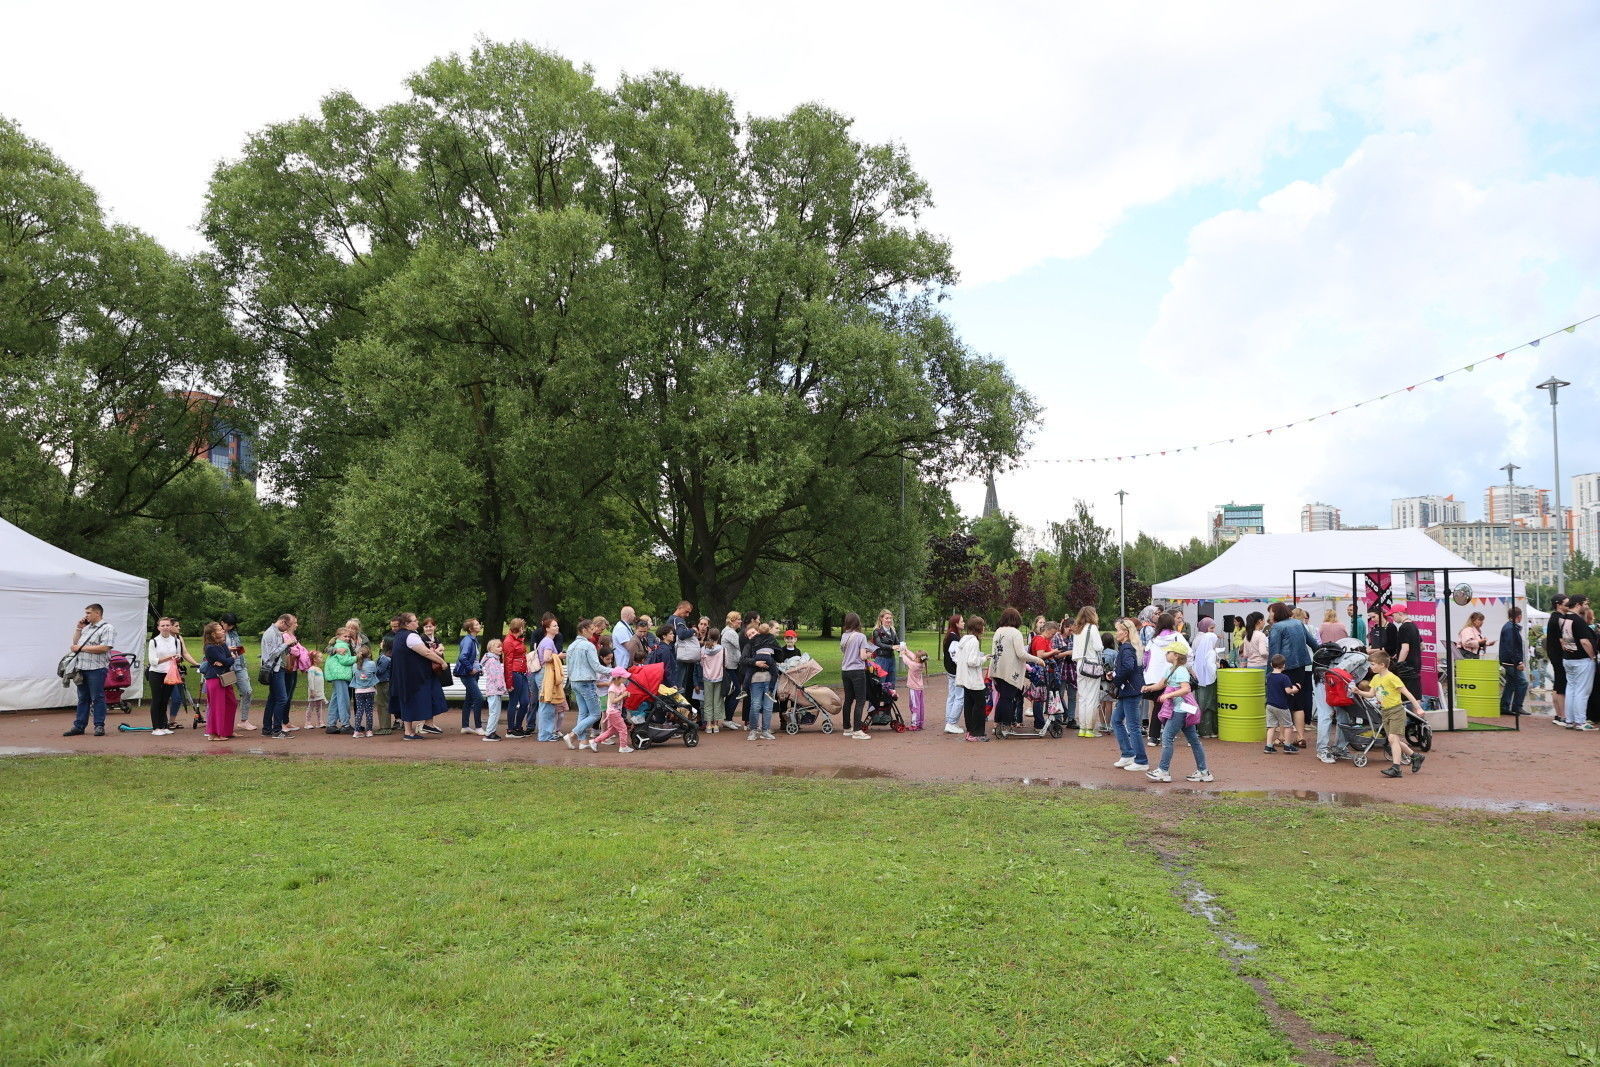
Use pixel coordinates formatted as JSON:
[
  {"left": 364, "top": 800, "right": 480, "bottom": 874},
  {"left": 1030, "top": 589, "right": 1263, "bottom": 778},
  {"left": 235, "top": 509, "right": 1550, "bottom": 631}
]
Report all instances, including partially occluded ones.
[{"left": 0, "top": 520, "right": 150, "bottom": 712}]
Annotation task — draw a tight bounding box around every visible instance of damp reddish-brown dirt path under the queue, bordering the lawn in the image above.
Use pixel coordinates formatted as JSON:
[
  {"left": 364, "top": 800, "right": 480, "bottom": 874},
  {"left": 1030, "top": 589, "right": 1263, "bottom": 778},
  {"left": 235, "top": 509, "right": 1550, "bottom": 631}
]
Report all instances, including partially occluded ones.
[{"left": 0, "top": 678, "right": 1600, "bottom": 813}]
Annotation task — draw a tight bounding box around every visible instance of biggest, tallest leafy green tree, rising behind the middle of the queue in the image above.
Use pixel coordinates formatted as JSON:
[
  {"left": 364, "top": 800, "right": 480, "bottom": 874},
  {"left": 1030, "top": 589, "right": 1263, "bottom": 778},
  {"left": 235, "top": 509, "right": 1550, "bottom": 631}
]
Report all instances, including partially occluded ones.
[{"left": 205, "top": 43, "right": 1037, "bottom": 625}]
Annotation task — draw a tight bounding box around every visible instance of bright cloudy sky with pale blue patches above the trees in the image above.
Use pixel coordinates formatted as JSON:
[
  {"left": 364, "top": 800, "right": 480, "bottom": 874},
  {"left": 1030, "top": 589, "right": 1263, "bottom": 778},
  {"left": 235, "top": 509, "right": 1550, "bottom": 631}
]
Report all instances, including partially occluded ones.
[{"left": 0, "top": 0, "right": 1600, "bottom": 537}]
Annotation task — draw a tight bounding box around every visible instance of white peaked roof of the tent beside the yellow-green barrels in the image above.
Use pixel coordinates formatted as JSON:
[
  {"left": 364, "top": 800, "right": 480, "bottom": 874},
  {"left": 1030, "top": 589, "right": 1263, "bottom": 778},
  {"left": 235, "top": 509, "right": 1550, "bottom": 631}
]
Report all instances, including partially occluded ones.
[{"left": 1152, "top": 530, "right": 1526, "bottom": 601}]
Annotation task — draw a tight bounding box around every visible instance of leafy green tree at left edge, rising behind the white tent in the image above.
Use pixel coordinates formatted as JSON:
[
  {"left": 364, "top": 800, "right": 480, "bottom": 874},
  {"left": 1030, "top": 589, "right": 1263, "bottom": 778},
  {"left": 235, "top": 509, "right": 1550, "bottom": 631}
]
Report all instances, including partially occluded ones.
[{"left": 0, "top": 118, "right": 267, "bottom": 611}]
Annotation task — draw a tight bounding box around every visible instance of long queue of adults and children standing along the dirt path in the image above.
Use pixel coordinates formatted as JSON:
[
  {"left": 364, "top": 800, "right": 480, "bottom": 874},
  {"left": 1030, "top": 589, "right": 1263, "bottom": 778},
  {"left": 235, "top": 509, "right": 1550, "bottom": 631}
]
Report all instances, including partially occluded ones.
[{"left": 56, "top": 597, "right": 1580, "bottom": 782}]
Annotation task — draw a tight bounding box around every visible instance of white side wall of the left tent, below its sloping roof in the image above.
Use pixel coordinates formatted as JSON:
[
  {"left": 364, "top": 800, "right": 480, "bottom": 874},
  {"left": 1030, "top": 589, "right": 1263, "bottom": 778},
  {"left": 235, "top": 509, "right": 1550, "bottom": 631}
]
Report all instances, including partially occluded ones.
[{"left": 0, "top": 589, "right": 149, "bottom": 712}]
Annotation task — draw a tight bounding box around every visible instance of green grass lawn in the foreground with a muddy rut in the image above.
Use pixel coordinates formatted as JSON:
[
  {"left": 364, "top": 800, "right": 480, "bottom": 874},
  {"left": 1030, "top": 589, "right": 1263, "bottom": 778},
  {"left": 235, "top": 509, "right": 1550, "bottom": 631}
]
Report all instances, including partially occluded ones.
[{"left": 0, "top": 757, "right": 1600, "bottom": 1067}]
